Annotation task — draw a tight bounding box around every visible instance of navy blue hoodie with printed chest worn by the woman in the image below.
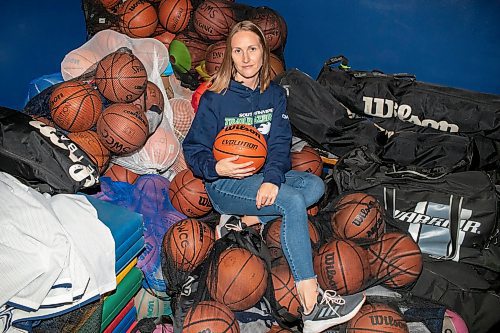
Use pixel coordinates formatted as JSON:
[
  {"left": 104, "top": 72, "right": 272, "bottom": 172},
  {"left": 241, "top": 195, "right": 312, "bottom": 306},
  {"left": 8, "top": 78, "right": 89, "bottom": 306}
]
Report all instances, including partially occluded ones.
[{"left": 182, "top": 80, "right": 292, "bottom": 187}]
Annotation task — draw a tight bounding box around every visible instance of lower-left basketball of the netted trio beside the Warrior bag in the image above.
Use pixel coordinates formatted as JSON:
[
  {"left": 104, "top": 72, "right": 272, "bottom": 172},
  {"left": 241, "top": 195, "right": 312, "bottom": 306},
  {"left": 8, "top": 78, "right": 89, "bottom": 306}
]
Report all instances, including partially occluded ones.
[{"left": 313, "top": 240, "right": 370, "bottom": 295}]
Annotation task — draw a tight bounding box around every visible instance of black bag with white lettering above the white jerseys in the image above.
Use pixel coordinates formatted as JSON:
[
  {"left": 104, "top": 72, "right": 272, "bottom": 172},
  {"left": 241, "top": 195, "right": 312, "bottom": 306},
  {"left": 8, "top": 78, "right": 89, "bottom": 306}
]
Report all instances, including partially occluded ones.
[{"left": 0, "top": 107, "right": 99, "bottom": 194}]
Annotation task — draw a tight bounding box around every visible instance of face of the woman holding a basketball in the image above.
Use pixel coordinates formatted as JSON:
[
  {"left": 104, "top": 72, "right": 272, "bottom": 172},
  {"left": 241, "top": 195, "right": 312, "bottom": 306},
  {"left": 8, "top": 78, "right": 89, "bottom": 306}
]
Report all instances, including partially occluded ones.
[{"left": 231, "top": 31, "right": 264, "bottom": 88}]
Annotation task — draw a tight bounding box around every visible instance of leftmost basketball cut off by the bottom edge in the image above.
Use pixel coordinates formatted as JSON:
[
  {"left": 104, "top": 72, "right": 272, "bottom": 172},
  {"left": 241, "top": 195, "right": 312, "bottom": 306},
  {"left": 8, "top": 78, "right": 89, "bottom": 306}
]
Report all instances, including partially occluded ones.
[{"left": 182, "top": 301, "right": 240, "bottom": 333}]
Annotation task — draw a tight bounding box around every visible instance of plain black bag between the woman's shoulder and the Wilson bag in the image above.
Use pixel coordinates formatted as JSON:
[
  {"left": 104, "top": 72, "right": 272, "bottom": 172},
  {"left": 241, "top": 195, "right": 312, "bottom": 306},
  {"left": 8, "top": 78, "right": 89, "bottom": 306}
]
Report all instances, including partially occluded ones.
[{"left": 275, "top": 69, "right": 385, "bottom": 156}]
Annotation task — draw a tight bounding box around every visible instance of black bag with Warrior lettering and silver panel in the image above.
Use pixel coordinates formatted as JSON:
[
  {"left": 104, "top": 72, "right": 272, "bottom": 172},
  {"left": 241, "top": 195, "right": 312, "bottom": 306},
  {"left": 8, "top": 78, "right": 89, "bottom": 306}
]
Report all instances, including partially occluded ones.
[{"left": 334, "top": 147, "right": 500, "bottom": 272}]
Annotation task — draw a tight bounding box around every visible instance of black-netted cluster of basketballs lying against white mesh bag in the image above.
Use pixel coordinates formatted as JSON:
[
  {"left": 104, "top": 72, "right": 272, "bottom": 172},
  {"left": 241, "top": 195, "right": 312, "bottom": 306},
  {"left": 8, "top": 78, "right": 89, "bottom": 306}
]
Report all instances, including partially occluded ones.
[{"left": 48, "top": 49, "right": 164, "bottom": 176}]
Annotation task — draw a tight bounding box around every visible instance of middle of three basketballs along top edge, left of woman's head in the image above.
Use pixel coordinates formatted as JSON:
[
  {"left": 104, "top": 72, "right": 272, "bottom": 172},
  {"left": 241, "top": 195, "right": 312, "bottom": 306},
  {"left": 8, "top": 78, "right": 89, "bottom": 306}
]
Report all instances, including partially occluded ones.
[{"left": 158, "top": 0, "right": 193, "bottom": 33}]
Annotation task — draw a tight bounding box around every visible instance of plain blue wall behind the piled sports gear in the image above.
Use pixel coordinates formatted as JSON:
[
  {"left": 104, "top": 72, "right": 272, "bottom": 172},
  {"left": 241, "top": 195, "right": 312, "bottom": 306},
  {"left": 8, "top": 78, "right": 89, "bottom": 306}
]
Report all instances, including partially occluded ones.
[{"left": 0, "top": 0, "right": 500, "bottom": 108}]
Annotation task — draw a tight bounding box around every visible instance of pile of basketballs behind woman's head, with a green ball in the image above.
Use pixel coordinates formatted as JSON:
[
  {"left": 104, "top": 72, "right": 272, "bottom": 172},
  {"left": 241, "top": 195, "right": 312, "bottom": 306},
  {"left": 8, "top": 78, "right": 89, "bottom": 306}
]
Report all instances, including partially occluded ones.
[{"left": 100, "top": 0, "right": 287, "bottom": 77}]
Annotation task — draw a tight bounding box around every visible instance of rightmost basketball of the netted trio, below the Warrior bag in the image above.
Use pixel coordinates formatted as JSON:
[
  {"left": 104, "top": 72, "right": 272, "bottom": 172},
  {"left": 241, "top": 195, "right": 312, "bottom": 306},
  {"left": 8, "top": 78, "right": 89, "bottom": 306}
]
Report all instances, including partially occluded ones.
[{"left": 367, "top": 232, "right": 423, "bottom": 288}]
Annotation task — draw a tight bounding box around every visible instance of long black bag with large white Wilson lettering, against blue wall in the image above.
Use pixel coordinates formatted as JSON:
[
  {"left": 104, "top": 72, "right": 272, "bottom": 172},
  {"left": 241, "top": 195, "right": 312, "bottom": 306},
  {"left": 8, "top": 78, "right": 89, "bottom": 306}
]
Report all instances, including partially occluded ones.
[{"left": 317, "top": 56, "right": 500, "bottom": 167}]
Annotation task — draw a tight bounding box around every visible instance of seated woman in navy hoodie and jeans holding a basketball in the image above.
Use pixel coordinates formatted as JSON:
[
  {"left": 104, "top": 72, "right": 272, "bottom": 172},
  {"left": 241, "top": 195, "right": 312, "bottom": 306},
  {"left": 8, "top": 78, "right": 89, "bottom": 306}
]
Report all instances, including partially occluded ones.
[{"left": 183, "top": 21, "right": 365, "bottom": 333}]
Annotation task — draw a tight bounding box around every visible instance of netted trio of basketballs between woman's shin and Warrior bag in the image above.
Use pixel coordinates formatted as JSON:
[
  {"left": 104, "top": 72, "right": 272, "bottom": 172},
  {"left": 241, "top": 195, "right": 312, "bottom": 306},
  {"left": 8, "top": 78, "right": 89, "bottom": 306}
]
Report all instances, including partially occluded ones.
[{"left": 313, "top": 193, "right": 422, "bottom": 295}]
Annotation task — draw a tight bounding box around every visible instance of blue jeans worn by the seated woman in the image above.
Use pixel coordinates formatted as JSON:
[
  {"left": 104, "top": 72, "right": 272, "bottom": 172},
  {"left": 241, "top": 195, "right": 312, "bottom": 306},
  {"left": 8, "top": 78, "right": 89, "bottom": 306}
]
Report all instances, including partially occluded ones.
[{"left": 205, "top": 170, "right": 325, "bottom": 282}]
